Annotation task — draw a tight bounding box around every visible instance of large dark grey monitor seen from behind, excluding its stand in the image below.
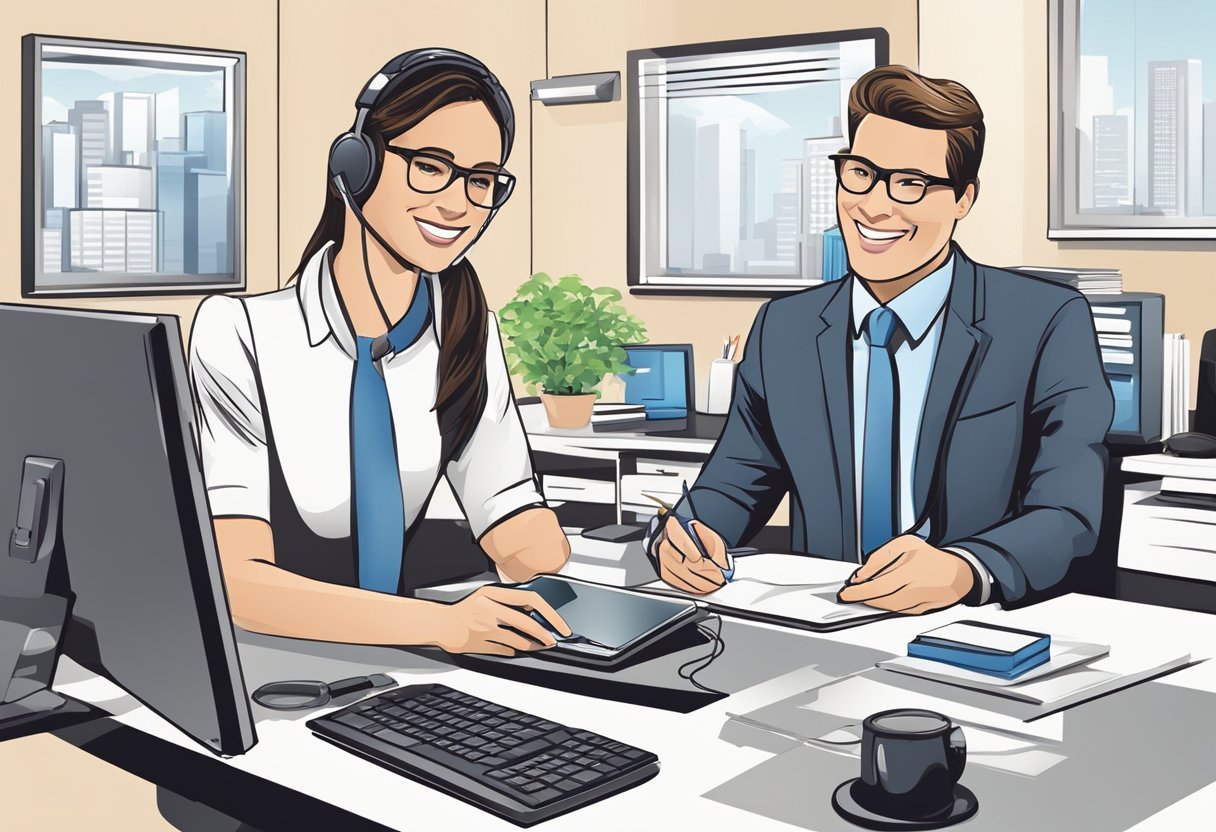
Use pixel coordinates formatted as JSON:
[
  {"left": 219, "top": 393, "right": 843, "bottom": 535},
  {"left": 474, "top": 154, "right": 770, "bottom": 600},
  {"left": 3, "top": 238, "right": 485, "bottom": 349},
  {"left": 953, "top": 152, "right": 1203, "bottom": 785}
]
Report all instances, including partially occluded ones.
[{"left": 0, "top": 304, "right": 257, "bottom": 755}]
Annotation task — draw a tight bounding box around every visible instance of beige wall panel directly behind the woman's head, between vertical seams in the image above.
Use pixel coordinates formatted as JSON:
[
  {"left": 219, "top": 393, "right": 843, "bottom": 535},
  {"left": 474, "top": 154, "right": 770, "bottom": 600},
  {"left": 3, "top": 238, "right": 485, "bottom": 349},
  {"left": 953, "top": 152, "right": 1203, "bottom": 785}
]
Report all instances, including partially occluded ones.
[{"left": 280, "top": 0, "right": 545, "bottom": 309}]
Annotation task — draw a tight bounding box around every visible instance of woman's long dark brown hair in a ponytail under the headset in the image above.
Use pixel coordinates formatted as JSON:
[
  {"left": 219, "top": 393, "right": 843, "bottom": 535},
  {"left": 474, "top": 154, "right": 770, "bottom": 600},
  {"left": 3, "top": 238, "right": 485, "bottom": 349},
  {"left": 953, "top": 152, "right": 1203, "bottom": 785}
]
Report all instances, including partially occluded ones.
[{"left": 292, "top": 71, "right": 513, "bottom": 463}]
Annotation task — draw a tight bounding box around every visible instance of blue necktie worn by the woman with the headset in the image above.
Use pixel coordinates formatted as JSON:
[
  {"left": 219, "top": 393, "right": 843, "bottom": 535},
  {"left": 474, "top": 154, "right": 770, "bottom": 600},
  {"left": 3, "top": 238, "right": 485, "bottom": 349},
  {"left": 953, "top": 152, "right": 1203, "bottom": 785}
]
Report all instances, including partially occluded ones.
[{"left": 350, "top": 279, "right": 430, "bottom": 594}]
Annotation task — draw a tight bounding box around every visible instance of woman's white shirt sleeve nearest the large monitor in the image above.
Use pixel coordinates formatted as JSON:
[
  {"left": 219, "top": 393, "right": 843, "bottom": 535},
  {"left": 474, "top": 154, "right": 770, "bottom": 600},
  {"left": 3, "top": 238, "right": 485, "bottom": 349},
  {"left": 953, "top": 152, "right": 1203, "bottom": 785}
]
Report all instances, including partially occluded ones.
[{"left": 190, "top": 296, "right": 270, "bottom": 522}]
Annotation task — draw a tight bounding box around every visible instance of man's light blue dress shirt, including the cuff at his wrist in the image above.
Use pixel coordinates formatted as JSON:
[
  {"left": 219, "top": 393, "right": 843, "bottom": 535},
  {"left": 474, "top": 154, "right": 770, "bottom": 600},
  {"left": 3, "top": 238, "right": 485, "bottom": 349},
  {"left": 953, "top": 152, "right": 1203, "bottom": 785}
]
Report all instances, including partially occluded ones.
[{"left": 850, "top": 254, "right": 991, "bottom": 603}]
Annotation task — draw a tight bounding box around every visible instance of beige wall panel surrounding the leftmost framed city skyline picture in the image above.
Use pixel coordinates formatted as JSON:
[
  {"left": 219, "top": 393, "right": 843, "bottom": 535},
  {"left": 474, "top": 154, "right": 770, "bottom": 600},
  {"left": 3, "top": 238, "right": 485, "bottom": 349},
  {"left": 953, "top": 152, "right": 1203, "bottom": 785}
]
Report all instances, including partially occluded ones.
[{"left": 0, "top": 0, "right": 278, "bottom": 333}]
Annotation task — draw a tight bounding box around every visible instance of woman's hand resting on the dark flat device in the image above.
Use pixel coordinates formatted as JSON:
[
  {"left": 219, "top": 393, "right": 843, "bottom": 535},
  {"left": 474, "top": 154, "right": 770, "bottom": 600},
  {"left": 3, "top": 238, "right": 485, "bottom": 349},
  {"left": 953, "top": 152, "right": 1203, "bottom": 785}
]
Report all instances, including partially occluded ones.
[{"left": 433, "top": 586, "right": 572, "bottom": 656}]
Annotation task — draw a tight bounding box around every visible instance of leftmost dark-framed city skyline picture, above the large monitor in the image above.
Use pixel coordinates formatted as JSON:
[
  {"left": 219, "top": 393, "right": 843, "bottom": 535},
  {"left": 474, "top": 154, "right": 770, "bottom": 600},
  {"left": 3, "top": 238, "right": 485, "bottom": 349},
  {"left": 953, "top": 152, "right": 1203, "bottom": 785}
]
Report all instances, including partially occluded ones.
[{"left": 22, "top": 34, "right": 246, "bottom": 297}]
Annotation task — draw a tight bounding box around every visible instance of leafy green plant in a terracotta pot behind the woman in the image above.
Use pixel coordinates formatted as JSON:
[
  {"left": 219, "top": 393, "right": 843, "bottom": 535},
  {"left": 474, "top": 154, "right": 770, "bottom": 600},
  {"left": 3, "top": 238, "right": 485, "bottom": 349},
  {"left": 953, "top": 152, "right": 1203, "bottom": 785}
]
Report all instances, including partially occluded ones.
[{"left": 499, "top": 272, "right": 646, "bottom": 428}]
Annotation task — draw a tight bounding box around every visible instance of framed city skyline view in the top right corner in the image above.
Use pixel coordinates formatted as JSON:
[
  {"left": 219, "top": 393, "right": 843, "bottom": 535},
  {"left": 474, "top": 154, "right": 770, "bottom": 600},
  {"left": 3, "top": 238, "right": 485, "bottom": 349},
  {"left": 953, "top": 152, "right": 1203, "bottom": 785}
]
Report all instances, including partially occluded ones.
[{"left": 1047, "top": 0, "right": 1216, "bottom": 240}]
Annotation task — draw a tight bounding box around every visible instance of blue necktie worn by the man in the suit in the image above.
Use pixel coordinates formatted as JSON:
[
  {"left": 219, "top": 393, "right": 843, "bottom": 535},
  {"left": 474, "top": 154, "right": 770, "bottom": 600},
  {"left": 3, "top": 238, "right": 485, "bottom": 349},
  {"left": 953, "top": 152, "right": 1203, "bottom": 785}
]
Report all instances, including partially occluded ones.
[{"left": 861, "top": 307, "right": 900, "bottom": 555}]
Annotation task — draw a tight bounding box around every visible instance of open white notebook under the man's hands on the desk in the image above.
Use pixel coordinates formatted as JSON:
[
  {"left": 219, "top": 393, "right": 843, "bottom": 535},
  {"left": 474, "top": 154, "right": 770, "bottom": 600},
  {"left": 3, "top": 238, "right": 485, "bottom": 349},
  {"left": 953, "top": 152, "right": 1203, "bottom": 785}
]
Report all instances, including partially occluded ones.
[{"left": 634, "top": 553, "right": 895, "bottom": 631}]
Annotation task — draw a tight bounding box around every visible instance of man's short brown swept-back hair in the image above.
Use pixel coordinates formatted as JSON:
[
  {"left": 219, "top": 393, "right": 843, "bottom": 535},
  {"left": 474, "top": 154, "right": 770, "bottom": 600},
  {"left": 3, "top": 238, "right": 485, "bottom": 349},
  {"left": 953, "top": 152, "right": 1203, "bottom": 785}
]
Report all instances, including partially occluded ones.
[{"left": 849, "top": 64, "right": 984, "bottom": 197}]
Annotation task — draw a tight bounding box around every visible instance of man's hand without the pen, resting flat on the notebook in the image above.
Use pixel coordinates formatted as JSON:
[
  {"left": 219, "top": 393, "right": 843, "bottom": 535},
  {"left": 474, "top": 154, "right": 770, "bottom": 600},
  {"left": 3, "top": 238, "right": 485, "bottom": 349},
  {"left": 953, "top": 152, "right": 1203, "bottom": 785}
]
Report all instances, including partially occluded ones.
[{"left": 837, "top": 534, "right": 975, "bottom": 615}]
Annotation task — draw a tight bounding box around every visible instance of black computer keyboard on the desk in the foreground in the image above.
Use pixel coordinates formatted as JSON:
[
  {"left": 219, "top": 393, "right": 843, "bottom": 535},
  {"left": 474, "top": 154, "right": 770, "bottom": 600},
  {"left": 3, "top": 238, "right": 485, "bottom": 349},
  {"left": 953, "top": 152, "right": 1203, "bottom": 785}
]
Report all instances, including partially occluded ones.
[{"left": 306, "top": 685, "right": 659, "bottom": 826}]
